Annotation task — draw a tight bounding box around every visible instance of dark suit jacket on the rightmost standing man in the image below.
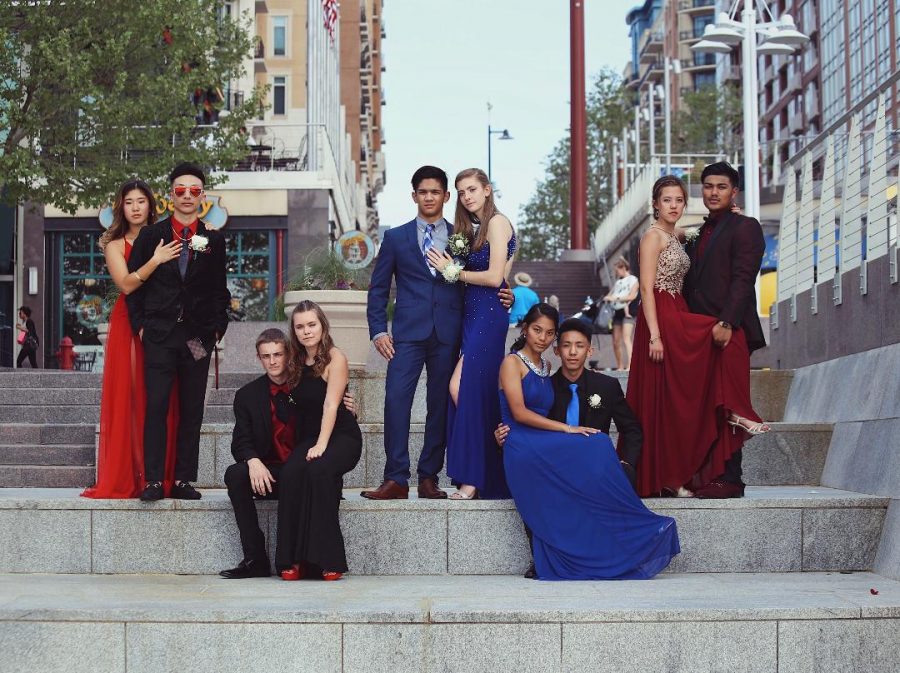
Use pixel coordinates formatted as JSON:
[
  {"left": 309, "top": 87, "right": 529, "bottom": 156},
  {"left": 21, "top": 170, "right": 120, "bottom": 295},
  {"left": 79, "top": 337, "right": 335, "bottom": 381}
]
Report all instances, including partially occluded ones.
[{"left": 684, "top": 213, "right": 766, "bottom": 352}]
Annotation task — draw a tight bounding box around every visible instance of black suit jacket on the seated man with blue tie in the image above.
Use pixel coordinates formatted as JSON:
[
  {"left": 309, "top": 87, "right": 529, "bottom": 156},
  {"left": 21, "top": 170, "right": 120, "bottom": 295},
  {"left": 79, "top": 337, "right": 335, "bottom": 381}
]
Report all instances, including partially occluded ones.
[{"left": 548, "top": 369, "right": 644, "bottom": 467}]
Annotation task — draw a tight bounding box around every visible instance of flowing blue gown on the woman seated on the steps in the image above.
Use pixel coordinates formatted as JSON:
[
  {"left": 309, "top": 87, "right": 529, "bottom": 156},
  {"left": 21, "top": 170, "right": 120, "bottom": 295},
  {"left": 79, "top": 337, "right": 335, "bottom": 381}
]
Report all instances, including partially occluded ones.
[{"left": 500, "top": 360, "right": 681, "bottom": 580}]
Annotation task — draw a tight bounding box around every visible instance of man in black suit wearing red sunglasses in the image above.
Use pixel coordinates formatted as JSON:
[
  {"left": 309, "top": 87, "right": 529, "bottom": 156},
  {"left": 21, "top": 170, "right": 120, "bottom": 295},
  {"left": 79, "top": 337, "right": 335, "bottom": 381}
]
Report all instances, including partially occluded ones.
[{"left": 126, "top": 163, "right": 231, "bottom": 501}]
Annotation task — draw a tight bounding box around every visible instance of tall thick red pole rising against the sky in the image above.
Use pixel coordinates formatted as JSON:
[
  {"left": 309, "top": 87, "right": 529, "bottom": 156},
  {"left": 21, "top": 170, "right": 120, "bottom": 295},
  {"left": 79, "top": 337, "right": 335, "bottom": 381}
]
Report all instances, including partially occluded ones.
[{"left": 569, "top": 0, "right": 588, "bottom": 250}]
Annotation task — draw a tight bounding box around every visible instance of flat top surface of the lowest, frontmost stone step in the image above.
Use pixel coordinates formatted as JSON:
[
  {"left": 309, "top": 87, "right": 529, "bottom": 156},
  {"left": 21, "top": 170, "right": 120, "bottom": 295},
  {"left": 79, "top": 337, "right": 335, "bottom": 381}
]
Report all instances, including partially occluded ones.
[{"left": 0, "top": 572, "right": 900, "bottom": 628}]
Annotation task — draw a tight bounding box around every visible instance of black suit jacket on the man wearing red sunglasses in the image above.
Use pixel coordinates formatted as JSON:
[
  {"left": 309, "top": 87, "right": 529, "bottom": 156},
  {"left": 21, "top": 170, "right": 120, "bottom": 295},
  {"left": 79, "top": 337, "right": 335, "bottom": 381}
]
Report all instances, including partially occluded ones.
[{"left": 125, "top": 219, "right": 231, "bottom": 348}]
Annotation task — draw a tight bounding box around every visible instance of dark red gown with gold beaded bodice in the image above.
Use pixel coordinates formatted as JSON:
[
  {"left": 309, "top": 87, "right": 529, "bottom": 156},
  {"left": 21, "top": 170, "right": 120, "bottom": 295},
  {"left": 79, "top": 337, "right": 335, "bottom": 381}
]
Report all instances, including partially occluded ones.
[{"left": 626, "top": 236, "right": 761, "bottom": 497}]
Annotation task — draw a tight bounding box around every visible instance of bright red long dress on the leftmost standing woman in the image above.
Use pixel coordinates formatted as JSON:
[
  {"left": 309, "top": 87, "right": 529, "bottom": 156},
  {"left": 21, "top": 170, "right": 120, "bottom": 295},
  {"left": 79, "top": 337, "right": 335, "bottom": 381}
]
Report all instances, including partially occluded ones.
[{"left": 81, "top": 240, "right": 178, "bottom": 498}]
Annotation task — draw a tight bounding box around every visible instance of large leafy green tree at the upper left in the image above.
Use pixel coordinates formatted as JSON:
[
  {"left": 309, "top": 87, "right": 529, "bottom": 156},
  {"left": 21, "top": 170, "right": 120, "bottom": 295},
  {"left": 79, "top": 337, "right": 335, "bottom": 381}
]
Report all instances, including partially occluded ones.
[{"left": 0, "top": 0, "right": 264, "bottom": 212}]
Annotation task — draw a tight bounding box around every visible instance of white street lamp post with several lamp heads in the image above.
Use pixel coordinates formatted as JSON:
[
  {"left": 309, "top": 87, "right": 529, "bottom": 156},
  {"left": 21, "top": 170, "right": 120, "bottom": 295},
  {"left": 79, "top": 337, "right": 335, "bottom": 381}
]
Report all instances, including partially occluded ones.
[{"left": 691, "top": 0, "right": 809, "bottom": 219}]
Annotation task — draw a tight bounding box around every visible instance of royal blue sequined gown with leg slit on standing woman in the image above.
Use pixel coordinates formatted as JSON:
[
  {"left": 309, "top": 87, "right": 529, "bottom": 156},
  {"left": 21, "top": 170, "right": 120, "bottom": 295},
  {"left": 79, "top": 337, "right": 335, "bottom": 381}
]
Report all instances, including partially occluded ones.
[{"left": 447, "top": 234, "right": 516, "bottom": 500}]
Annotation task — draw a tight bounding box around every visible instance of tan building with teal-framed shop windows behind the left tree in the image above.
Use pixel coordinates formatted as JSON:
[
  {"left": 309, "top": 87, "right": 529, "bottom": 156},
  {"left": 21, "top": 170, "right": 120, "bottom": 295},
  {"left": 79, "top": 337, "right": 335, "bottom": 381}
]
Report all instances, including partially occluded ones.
[{"left": 0, "top": 0, "right": 385, "bottom": 366}]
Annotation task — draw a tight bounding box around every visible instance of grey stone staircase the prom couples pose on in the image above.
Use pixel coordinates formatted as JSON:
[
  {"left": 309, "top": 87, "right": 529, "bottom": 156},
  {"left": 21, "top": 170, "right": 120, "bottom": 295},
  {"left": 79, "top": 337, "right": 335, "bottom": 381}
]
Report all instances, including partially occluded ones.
[{"left": 0, "top": 364, "right": 900, "bottom": 673}]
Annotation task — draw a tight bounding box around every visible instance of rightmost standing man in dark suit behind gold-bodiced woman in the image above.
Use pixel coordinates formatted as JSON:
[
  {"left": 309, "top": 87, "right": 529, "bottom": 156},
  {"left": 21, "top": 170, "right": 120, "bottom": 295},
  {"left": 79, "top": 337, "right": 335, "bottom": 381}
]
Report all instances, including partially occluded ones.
[{"left": 684, "top": 161, "right": 766, "bottom": 498}]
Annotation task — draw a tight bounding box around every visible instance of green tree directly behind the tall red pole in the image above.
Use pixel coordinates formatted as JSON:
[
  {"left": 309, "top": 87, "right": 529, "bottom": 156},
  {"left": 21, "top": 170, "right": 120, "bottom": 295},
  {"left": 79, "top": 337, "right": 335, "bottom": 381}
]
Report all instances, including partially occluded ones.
[{"left": 518, "top": 69, "right": 631, "bottom": 260}]
